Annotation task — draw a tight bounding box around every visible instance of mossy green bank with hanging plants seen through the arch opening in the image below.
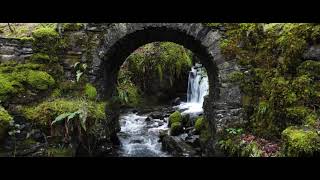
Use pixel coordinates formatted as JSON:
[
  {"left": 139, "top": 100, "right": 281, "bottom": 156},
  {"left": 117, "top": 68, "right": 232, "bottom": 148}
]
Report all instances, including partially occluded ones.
[{"left": 127, "top": 42, "right": 192, "bottom": 91}]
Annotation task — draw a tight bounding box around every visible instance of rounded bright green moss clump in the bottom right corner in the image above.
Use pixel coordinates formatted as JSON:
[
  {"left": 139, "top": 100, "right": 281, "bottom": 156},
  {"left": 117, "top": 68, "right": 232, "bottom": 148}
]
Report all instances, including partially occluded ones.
[{"left": 282, "top": 126, "right": 320, "bottom": 157}]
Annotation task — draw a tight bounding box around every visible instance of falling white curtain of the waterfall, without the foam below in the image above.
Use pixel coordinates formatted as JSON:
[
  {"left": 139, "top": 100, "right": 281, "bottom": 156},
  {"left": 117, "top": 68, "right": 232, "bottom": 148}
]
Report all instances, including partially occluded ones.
[{"left": 187, "top": 64, "right": 209, "bottom": 105}]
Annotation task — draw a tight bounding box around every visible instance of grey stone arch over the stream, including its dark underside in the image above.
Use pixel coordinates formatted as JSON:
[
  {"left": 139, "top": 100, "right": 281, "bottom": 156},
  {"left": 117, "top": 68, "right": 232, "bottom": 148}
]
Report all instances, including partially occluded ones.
[{"left": 88, "top": 23, "right": 240, "bottom": 155}]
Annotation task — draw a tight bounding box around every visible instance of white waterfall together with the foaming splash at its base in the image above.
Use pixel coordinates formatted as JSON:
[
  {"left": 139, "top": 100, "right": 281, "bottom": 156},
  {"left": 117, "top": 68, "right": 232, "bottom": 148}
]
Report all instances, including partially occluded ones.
[{"left": 178, "top": 64, "right": 209, "bottom": 114}]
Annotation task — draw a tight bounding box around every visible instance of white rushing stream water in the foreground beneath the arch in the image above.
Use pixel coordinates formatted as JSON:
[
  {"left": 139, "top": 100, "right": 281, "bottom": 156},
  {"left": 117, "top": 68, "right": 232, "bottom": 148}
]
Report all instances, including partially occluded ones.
[{"left": 118, "top": 113, "right": 168, "bottom": 157}]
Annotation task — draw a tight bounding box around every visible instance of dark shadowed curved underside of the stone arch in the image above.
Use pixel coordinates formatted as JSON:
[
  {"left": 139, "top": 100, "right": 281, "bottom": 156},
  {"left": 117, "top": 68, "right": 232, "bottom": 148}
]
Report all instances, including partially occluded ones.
[{"left": 101, "top": 27, "right": 219, "bottom": 101}]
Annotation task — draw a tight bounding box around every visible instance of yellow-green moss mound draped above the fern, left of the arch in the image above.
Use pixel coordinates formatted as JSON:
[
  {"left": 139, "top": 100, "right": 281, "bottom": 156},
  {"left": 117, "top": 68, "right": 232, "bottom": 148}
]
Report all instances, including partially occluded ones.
[{"left": 21, "top": 98, "right": 105, "bottom": 127}]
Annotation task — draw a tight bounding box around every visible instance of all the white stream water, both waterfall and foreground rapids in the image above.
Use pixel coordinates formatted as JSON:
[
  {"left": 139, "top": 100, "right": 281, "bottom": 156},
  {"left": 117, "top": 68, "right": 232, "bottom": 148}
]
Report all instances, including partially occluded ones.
[{"left": 118, "top": 64, "right": 208, "bottom": 157}]
